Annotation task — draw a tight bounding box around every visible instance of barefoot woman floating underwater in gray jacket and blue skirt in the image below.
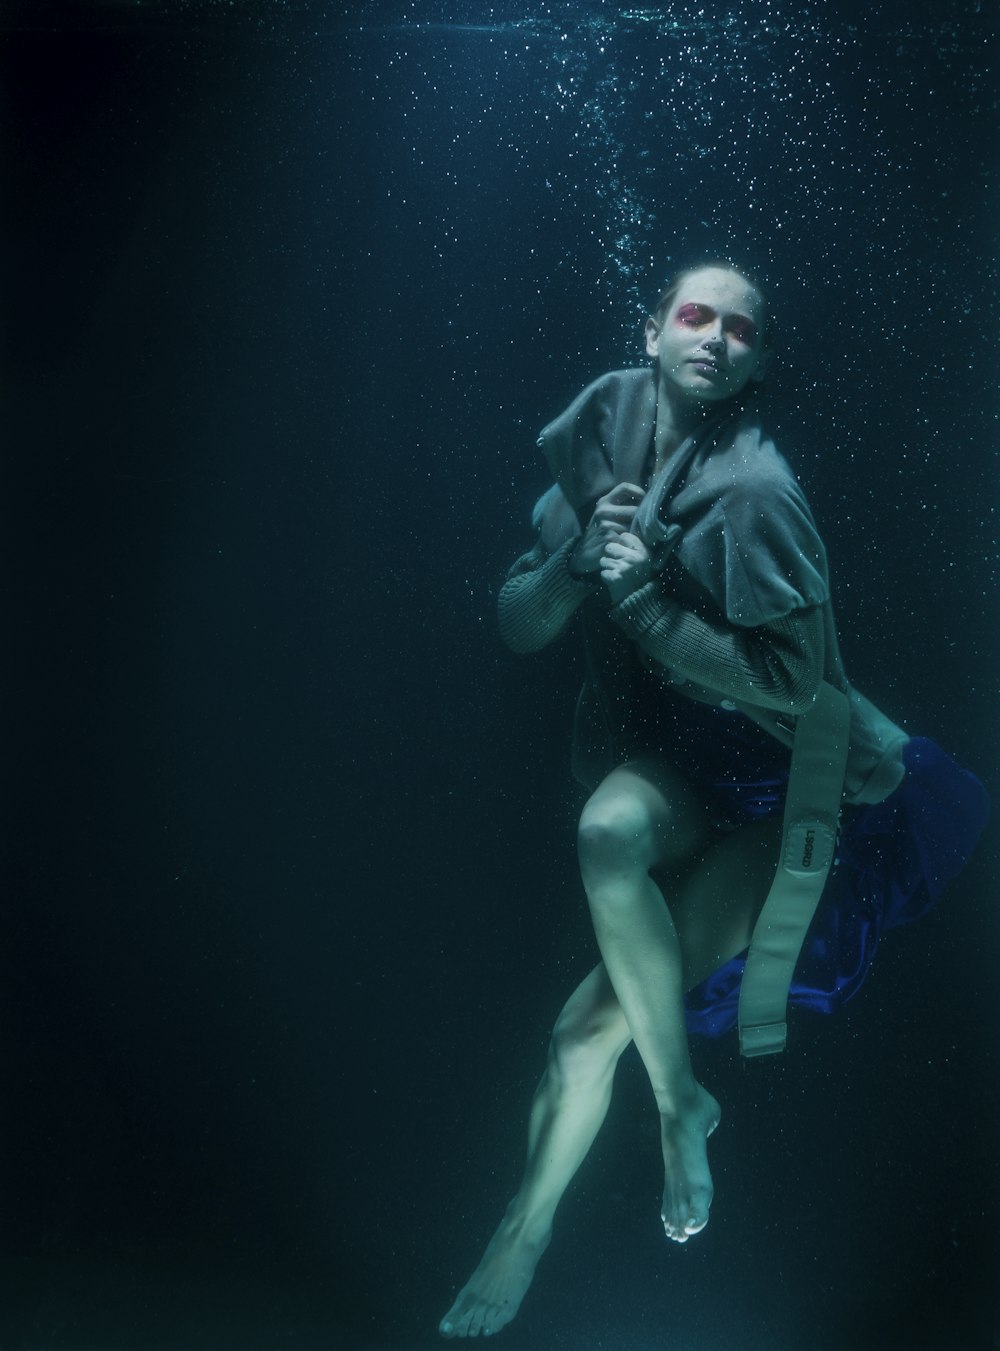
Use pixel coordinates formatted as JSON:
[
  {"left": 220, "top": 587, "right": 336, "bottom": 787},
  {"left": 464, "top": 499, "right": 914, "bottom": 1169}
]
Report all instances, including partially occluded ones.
[{"left": 441, "top": 263, "right": 986, "bottom": 1336}]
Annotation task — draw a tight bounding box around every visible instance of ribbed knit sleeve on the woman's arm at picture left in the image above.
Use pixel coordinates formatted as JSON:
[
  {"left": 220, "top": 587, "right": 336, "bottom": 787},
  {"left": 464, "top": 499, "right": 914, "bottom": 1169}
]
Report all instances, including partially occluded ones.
[{"left": 497, "top": 539, "right": 600, "bottom": 653}]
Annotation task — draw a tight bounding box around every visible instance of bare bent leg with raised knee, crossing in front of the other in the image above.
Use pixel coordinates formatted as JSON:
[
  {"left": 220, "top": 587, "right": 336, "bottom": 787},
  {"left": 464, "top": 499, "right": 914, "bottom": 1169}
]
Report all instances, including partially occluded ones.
[{"left": 580, "top": 761, "right": 720, "bottom": 1243}]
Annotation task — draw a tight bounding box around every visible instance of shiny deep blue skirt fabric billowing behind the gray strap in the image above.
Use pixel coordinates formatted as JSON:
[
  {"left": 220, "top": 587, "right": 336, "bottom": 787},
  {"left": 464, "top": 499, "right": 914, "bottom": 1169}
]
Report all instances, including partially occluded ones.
[{"left": 685, "top": 740, "right": 989, "bottom": 1036}]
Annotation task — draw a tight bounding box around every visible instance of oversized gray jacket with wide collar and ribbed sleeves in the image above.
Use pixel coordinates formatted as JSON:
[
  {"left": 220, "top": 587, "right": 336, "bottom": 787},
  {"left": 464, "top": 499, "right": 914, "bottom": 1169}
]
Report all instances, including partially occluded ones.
[{"left": 499, "top": 369, "right": 907, "bottom": 802}]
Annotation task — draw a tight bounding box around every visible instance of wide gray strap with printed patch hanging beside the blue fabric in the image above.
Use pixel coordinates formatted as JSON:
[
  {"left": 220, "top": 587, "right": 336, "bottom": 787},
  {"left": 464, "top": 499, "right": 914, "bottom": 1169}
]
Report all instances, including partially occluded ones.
[{"left": 739, "top": 681, "right": 850, "bottom": 1056}]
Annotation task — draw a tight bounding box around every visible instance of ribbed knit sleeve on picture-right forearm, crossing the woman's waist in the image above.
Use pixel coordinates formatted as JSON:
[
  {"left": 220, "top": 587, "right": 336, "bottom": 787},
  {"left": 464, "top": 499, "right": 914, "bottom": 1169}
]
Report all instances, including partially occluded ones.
[{"left": 611, "top": 582, "right": 824, "bottom": 713}]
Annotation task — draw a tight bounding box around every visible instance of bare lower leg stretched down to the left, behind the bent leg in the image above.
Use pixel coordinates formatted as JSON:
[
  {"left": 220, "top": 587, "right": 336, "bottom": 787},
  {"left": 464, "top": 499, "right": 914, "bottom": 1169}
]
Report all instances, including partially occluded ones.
[{"left": 441, "top": 966, "right": 631, "bottom": 1337}]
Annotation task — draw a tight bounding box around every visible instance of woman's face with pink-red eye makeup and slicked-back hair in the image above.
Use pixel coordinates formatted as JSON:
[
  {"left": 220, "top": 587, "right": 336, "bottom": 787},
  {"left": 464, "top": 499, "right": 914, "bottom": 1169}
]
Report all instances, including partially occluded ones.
[{"left": 646, "top": 267, "right": 766, "bottom": 407}]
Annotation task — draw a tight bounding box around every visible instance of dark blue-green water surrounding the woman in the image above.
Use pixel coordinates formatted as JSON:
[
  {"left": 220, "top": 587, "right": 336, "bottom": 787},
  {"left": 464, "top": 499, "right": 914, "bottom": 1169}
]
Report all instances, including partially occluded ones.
[{"left": 0, "top": 0, "right": 1000, "bottom": 1351}]
